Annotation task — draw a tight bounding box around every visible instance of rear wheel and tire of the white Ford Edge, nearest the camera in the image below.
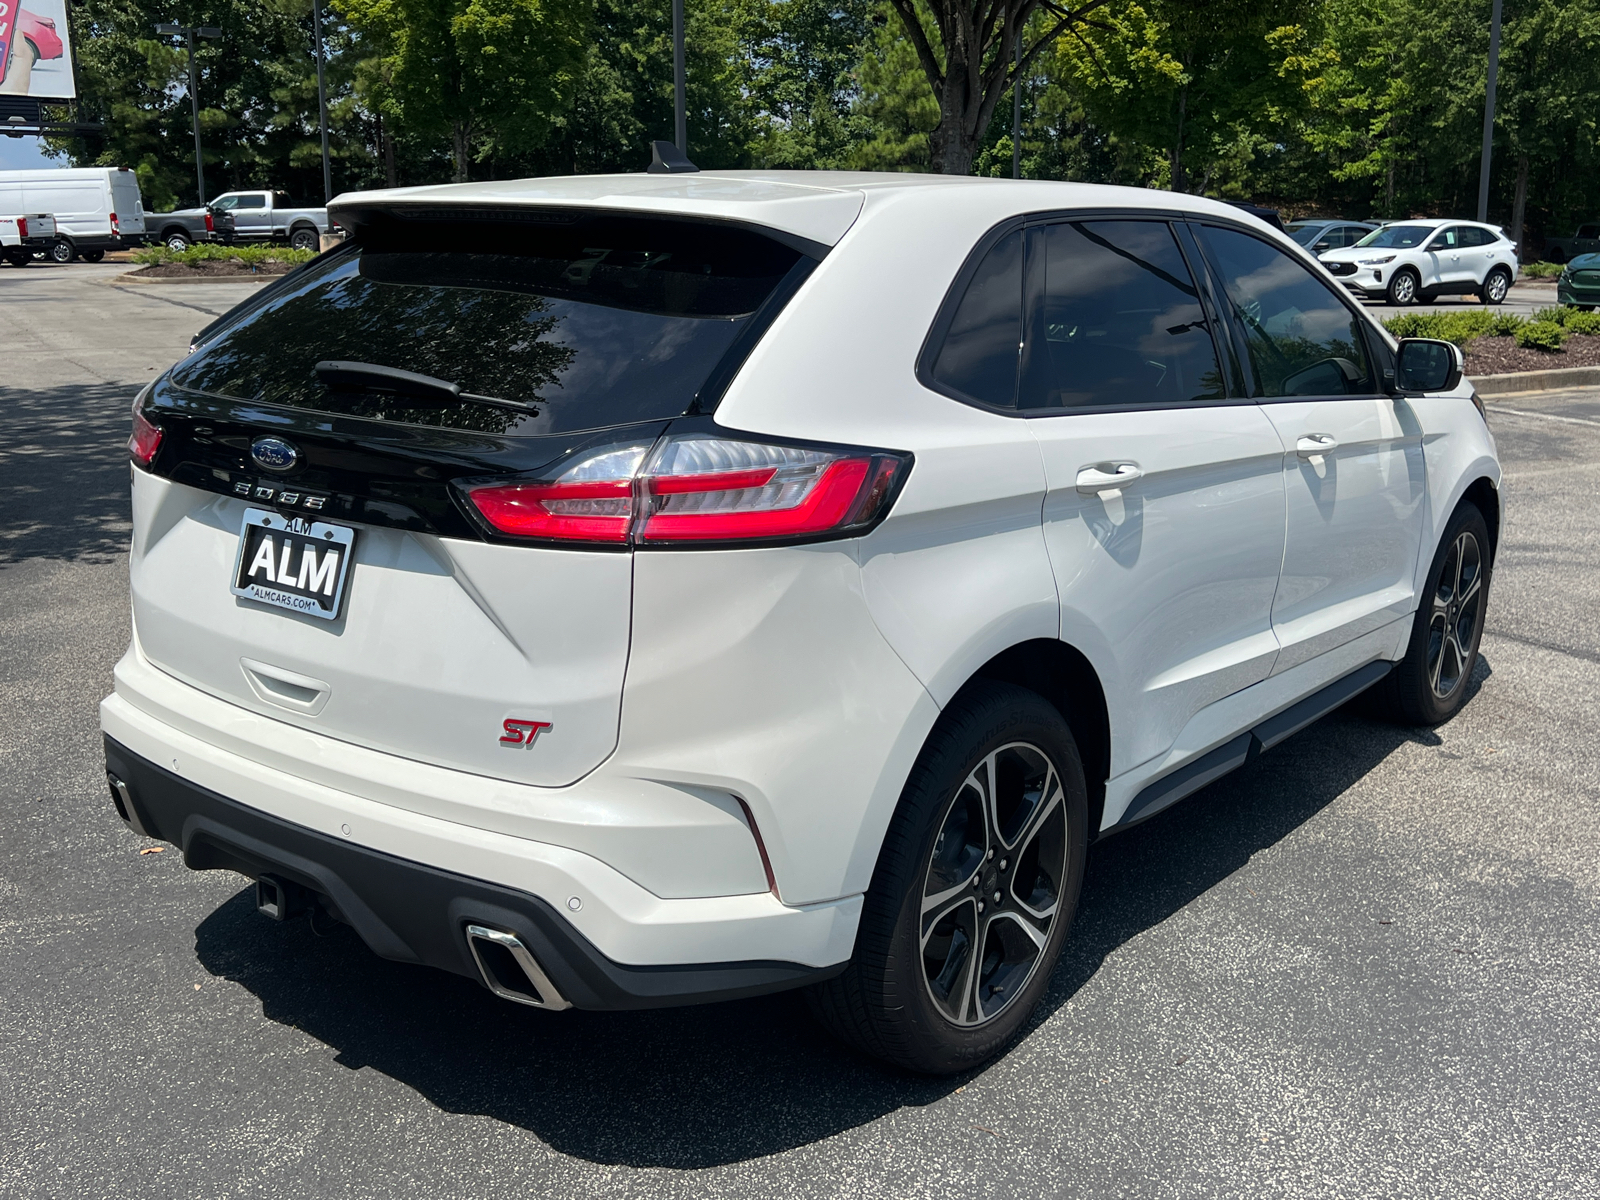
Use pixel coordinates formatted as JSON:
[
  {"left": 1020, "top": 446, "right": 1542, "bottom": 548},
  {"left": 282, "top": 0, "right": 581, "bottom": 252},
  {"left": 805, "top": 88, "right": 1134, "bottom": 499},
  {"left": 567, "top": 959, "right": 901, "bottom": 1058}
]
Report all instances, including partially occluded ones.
[{"left": 808, "top": 680, "right": 1088, "bottom": 1075}]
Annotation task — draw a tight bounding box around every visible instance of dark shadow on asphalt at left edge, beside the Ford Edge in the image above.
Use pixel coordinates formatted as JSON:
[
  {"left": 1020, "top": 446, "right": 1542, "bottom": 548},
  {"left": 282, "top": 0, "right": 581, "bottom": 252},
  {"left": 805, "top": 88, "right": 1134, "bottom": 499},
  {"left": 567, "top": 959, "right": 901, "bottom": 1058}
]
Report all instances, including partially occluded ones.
[{"left": 0, "top": 384, "right": 139, "bottom": 566}]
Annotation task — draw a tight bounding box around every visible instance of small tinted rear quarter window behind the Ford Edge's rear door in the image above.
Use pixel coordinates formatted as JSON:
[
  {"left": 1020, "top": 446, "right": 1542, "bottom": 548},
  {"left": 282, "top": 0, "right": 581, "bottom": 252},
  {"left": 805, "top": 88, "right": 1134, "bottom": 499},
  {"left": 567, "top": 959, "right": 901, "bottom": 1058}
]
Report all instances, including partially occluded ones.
[{"left": 933, "top": 230, "right": 1022, "bottom": 408}]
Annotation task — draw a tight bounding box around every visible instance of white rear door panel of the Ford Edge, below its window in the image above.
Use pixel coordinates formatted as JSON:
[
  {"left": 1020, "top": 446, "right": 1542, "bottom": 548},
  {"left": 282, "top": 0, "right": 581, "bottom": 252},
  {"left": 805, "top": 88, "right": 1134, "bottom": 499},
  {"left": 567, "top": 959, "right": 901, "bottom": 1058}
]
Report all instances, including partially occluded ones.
[{"left": 1027, "top": 405, "right": 1283, "bottom": 774}]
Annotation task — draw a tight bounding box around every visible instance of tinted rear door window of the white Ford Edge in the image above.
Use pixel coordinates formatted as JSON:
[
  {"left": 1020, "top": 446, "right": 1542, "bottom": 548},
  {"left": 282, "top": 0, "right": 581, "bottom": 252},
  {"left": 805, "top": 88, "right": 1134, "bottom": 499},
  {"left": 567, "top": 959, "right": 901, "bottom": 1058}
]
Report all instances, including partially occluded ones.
[{"left": 1022, "top": 221, "right": 1222, "bottom": 408}]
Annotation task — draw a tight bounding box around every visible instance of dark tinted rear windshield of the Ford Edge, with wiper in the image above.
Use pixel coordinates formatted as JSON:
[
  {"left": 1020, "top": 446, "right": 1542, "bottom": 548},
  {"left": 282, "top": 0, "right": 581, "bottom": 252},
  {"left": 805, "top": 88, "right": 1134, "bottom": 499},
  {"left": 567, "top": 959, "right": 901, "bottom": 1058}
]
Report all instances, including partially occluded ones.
[{"left": 173, "top": 216, "right": 800, "bottom": 435}]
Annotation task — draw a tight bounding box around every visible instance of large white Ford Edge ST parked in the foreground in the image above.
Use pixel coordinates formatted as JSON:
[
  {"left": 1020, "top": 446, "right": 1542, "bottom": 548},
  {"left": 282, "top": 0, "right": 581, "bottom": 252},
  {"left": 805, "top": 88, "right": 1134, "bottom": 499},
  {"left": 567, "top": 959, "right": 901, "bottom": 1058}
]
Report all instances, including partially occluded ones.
[{"left": 101, "top": 173, "right": 1501, "bottom": 1072}]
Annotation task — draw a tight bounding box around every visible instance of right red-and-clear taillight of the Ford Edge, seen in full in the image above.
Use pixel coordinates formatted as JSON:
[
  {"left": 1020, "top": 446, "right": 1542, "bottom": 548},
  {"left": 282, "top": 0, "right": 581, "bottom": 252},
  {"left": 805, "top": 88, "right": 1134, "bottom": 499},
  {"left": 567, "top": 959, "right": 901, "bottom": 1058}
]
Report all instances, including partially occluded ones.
[{"left": 467, "top": 434, "right": 910, "bottom": 546}]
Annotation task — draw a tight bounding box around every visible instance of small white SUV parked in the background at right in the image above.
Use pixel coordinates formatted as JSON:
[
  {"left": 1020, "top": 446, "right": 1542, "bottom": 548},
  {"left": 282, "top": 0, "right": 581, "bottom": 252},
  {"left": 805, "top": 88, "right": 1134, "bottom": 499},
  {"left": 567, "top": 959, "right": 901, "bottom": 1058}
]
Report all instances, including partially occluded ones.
[{"left": 1320, "top": 219, "right": 1517, "bottom": 304}]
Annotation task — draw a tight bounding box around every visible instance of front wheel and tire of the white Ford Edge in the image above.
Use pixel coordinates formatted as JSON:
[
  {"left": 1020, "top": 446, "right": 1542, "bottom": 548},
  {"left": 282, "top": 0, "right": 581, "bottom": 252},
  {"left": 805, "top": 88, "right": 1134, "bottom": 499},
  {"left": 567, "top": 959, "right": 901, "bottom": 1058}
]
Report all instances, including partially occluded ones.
[{"left": 1373, "top": 501, "right": 1493, "bottom": 725}]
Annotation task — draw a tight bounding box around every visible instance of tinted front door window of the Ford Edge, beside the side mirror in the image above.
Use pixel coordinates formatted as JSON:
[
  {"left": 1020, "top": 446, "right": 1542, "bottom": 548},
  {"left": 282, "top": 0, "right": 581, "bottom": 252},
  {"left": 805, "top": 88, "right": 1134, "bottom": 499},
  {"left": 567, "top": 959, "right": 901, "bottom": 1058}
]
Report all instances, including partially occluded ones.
[{"left": 1200, "top": 226, "right": 1371, "bottom": 397}]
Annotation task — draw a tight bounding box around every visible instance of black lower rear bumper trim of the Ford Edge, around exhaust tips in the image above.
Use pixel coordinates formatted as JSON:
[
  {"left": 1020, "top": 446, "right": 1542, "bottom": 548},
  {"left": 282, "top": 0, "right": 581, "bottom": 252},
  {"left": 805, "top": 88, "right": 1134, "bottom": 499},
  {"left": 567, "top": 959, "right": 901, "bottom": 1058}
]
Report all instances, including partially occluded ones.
[{"left": 106, "top": 738, "right": 845, "bottom": 1010}]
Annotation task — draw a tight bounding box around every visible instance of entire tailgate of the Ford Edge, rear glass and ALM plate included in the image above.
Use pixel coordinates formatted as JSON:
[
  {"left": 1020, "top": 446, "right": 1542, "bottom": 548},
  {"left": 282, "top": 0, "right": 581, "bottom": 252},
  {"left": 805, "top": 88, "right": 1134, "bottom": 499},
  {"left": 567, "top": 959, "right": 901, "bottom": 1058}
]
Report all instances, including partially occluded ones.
[{"left": 131, "top": 213, "right": 805, "bottom": 786}]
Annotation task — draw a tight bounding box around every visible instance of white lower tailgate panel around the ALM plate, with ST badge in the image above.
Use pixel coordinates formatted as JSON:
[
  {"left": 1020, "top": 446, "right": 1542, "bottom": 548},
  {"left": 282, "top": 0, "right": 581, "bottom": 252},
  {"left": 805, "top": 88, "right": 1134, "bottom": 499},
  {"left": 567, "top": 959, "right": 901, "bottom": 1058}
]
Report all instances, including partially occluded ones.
[{"left": 128, "top": 470, "right": 632, "bottom": 787}]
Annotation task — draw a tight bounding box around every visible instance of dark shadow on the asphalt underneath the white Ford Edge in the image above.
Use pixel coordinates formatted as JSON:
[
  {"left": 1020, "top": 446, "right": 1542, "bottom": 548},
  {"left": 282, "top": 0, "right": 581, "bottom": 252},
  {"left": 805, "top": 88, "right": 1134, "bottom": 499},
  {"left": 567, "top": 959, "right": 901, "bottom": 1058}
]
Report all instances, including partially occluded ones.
[{"left": 195, "top": 662, "right": 1488, "bottom": 1170}]
